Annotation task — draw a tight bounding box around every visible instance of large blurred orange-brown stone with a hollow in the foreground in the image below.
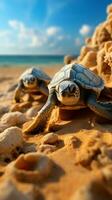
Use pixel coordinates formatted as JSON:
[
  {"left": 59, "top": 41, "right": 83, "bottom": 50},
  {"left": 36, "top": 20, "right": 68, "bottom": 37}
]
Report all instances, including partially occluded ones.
[{"left": 6, "top": 153, "right": 53, "bottom": 183}]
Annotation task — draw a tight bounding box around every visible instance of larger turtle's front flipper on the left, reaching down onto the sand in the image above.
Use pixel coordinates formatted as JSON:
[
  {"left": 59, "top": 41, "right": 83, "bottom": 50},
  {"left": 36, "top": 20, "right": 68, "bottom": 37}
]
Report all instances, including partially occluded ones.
[{"left": 23, "top": 89, "right": 56, "bottom": 133}]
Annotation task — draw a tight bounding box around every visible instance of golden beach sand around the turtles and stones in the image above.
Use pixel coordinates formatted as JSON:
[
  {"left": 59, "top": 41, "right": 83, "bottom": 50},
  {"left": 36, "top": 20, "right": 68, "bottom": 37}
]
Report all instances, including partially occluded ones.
[{"left": 0, "top": 67, "right": 112, "bottom": 200}]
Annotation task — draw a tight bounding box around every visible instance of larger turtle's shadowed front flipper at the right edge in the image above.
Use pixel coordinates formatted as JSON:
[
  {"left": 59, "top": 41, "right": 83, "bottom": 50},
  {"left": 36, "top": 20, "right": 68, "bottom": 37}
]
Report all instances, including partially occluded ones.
[{"left": 87, "top": 94, "right": 112, "bottom": 120}]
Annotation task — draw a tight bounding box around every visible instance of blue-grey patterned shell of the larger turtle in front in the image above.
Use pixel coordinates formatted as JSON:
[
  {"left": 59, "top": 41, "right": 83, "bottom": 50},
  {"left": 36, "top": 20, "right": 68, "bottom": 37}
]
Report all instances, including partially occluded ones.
[{"left": 48, "top": 64, "right": 104, "bottom": 94}]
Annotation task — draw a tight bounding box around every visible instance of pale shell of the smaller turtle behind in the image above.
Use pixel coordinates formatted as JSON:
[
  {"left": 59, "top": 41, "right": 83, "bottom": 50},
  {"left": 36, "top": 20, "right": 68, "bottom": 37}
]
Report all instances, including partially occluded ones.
[{"left": 19, "top": 67, "right": 51, "bottom": 84}]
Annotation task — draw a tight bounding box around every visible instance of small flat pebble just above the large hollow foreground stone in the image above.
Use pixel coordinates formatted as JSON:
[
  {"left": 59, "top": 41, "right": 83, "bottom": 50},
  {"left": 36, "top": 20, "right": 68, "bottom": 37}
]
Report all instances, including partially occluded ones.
[{"left": 38, "top": 144, "right": 57, "bottom": 154}]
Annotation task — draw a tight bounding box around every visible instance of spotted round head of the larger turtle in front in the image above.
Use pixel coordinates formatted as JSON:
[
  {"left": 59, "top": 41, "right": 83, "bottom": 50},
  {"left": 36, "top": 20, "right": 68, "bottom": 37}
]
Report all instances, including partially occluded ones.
[{"left": 56, "top": 81, "right": 80, "bottom": 106}]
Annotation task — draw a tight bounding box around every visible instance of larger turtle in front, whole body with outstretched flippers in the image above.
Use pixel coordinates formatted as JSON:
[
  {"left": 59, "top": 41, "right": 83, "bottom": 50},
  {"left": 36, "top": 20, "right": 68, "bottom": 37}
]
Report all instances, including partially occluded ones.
[{"left": 24, "top": 64, "right": 112, "bottom": 133}]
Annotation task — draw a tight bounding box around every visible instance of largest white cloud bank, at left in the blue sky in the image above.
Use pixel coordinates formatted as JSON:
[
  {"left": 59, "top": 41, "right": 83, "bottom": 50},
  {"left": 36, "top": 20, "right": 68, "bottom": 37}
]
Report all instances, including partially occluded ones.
[{"left": 8, "top": 20, "right": 65, "bottom": 48}]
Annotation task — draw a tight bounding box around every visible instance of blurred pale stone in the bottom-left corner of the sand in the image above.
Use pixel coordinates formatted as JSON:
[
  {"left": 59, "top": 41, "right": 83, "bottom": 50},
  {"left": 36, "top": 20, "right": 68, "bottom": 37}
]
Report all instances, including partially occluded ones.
[{"left": 0, "top": 180, "right": 29, "bottom": 200}]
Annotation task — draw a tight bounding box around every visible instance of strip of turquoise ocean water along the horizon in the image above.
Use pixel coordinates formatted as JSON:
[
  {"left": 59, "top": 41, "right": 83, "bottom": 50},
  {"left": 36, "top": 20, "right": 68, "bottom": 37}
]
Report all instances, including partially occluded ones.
[{"left": 0, "top": 55, "right": 64, "bottom": 67}]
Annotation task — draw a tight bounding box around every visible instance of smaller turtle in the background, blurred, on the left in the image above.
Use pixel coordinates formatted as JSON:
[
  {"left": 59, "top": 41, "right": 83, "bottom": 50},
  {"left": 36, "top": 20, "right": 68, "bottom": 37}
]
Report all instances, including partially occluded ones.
[{"left": 14, "top": 67, "right": 51, "bottom": 102}]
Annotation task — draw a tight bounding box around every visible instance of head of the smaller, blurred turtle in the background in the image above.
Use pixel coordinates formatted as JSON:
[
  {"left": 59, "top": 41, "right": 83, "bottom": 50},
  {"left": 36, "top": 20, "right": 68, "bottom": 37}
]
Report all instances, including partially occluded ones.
[{"left": 23, "top": 74, "right": 37, "bottom": 88}]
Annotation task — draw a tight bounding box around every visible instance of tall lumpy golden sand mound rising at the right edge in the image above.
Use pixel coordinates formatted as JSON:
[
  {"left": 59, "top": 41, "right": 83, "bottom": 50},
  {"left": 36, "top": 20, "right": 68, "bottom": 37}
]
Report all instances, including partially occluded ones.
[{"left": 64, "top": 4, "right": 112, "bottom": 83}]
